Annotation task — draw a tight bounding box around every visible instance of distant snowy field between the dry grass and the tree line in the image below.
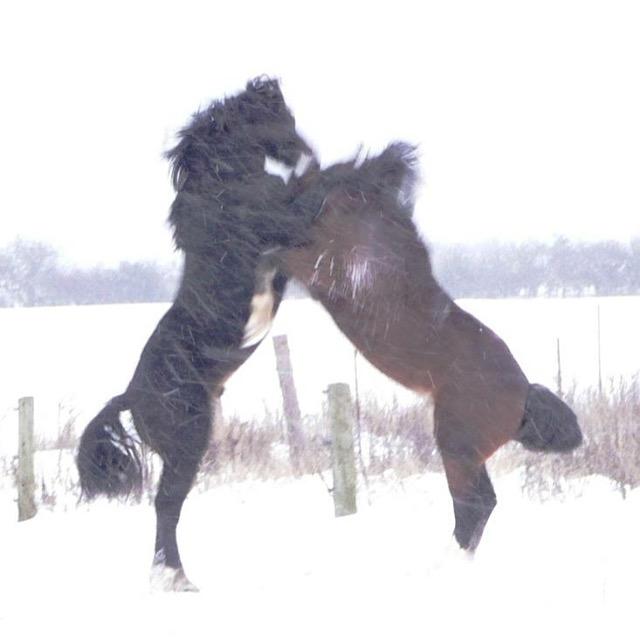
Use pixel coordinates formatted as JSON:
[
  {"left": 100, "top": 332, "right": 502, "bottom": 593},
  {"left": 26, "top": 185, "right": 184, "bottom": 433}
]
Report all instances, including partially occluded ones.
[{"left": 0, "top": 297, "right": 640, "bottom": 453}]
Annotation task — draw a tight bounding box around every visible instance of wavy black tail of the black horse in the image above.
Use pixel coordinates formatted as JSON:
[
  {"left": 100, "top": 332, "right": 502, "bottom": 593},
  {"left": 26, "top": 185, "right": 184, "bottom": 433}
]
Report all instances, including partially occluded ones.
[{"left": 76, "top": 395, "right": 142, "bottom": 499}]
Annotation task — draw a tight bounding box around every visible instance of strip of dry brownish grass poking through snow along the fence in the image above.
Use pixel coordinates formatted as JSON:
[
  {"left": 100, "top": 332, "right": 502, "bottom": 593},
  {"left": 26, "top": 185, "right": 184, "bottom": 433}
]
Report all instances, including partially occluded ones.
[{"left": 0, "top": 378, "right": 640, "bottom": 505}]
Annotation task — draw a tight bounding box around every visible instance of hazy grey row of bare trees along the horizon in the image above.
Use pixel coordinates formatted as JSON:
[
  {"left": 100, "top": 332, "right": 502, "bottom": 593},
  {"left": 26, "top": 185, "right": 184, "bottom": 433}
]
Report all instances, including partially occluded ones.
[{"left": 0, "top": 238, "right": 640, "bottom": 307}]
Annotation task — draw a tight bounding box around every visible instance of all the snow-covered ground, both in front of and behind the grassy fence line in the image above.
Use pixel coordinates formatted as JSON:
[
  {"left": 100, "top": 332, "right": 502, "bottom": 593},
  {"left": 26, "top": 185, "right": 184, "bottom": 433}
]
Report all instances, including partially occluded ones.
[{"left": 0, "top": 298, "right": 640, "bottom": 640}]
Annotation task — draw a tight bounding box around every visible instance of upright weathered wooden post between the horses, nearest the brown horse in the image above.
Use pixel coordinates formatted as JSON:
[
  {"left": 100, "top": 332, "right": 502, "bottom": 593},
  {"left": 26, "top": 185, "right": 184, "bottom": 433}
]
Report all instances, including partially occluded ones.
[{"left": 327, "top": 382, "right": 357, "bottom": 517}]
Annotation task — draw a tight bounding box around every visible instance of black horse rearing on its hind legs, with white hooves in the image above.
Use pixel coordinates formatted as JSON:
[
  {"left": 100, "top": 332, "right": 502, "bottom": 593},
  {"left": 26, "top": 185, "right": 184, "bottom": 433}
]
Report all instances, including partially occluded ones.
[{"left": 77, "top": 78, "right": 319, "bottom": 590}]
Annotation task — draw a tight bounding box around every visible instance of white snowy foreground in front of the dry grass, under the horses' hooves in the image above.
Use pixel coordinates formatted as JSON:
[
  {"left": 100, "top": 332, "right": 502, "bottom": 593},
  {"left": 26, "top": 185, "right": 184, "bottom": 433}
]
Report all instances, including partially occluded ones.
[{"left": 0, "top": 474, "right": 640, "bottom": 640}]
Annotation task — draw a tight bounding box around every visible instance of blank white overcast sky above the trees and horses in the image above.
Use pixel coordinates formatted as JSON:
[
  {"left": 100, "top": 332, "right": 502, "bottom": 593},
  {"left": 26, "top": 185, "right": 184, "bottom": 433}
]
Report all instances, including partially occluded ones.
[{"left": 0, "top": 0, "right": 640, "bottom": 264}]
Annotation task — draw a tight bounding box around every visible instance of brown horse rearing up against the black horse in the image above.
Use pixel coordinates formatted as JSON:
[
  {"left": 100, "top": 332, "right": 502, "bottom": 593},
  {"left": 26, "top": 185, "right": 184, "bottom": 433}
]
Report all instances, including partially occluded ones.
[{"left": 282, "top": 144, "right": 581, "bottom": 550}]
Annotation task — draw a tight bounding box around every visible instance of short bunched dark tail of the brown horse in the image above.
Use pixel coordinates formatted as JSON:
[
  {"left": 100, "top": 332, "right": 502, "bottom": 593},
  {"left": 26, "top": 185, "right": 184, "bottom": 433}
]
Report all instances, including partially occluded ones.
[{"left": 515, "top": 384, "right": 582, "bottom": 452}]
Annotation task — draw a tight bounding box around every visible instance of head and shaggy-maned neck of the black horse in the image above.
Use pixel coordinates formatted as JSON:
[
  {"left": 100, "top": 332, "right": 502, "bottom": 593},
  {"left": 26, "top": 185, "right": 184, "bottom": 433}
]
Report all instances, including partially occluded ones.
[{"left": 166, "top": 77, "right": 311, "bottom": 254}]
